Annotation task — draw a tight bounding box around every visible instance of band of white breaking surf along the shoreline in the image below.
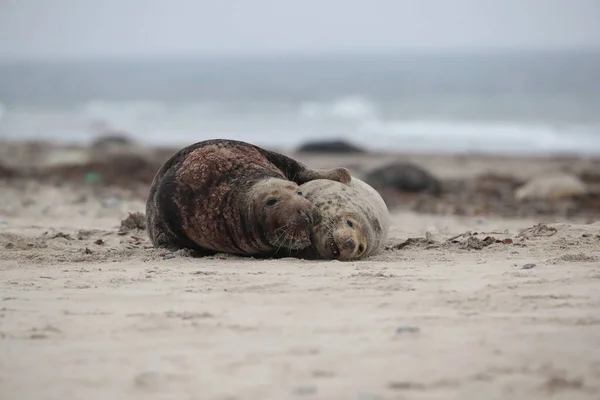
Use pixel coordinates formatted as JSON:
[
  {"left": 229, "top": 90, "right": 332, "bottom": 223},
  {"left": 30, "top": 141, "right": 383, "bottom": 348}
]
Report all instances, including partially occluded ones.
[{"left": 0, "top": 101, "right": 600, "bottom": 154}]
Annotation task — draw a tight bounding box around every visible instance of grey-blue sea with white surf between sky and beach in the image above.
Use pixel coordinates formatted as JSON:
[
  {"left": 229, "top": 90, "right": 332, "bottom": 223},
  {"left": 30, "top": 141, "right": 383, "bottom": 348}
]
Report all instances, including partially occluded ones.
[{"left": 0, "top": 52, "right": 600, "bottom": 154}]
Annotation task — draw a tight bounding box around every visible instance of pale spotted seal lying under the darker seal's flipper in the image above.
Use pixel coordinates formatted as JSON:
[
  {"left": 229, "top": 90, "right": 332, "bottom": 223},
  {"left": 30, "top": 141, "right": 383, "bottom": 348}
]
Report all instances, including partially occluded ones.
[{"left": 288, "top": 177, "right": 390, "bottom": 261}]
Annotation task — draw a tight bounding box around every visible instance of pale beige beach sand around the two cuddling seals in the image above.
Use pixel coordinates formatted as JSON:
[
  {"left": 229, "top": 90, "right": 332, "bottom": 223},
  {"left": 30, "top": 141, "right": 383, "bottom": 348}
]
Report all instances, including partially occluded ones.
[{"left": 0, "top": 142, "right": 600, "bottom": 400}]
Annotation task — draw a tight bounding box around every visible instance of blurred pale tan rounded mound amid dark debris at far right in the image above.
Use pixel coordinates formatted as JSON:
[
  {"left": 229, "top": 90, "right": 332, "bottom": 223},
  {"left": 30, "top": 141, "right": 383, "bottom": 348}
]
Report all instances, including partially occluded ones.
[{"left": 514, "top": 173, "right": 588, "bottom": 201}]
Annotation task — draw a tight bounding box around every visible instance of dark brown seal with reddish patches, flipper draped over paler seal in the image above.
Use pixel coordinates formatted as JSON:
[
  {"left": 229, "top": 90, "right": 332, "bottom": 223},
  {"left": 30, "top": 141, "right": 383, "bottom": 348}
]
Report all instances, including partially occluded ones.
[{"left": 146, "top": 139, "right": 351, "bottom": 257}]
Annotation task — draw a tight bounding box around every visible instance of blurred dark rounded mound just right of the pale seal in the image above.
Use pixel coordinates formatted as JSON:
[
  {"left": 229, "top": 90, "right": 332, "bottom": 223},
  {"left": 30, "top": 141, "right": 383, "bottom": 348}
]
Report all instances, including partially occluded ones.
[{"left": 364, "top": 162, "right": 442, "bottom": 195}]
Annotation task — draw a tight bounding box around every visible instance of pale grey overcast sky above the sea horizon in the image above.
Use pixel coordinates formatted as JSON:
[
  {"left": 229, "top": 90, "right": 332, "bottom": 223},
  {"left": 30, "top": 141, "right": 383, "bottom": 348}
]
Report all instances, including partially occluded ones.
[{"left": 0, "top": 0, "right": 600, "bottom": 57}]
